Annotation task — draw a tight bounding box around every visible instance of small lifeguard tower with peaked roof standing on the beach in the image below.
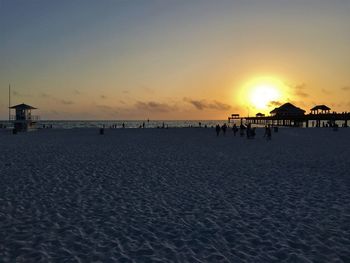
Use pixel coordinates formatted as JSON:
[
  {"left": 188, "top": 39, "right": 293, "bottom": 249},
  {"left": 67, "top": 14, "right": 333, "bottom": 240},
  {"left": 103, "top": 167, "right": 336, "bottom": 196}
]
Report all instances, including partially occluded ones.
[{"left": 10, "top": 103, "right": 39, "bottom": 131}]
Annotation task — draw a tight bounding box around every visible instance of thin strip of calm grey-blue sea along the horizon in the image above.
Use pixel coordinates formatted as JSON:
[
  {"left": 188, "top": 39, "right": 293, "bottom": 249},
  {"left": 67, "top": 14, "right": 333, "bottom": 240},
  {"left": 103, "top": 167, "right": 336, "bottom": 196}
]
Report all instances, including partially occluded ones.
[{"left": 0, "top": 120, "right": 238, "bottom": 129}]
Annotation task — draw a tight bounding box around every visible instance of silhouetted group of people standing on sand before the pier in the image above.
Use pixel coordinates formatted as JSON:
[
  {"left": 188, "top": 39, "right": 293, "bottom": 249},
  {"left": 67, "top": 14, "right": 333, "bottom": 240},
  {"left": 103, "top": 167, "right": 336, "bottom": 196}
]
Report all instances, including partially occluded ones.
[{"left": 215, "top": 123, "right": 272, "bottom": 140}]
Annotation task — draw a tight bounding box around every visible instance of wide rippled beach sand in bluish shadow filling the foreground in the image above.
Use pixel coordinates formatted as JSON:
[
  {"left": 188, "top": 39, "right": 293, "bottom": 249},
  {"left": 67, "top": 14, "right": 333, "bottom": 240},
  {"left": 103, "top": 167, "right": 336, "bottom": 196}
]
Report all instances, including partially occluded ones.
[{"left": 0, "top": 128, "right": 350, "bottom": 262}]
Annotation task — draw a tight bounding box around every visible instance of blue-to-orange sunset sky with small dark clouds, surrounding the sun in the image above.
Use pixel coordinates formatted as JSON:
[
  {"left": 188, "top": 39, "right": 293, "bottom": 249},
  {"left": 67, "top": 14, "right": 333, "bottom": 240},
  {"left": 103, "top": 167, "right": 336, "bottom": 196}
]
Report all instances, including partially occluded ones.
[{"left": 0, "top": 0, "right": 350, "bottom": 120}]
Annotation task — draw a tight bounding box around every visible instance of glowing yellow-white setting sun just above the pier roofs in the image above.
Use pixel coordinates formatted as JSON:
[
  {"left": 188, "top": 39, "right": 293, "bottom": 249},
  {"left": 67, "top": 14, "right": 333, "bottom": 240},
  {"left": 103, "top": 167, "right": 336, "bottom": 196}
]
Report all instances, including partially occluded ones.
[{"left": 240, "top": 78, "right": 287, "bottom": 113}]
